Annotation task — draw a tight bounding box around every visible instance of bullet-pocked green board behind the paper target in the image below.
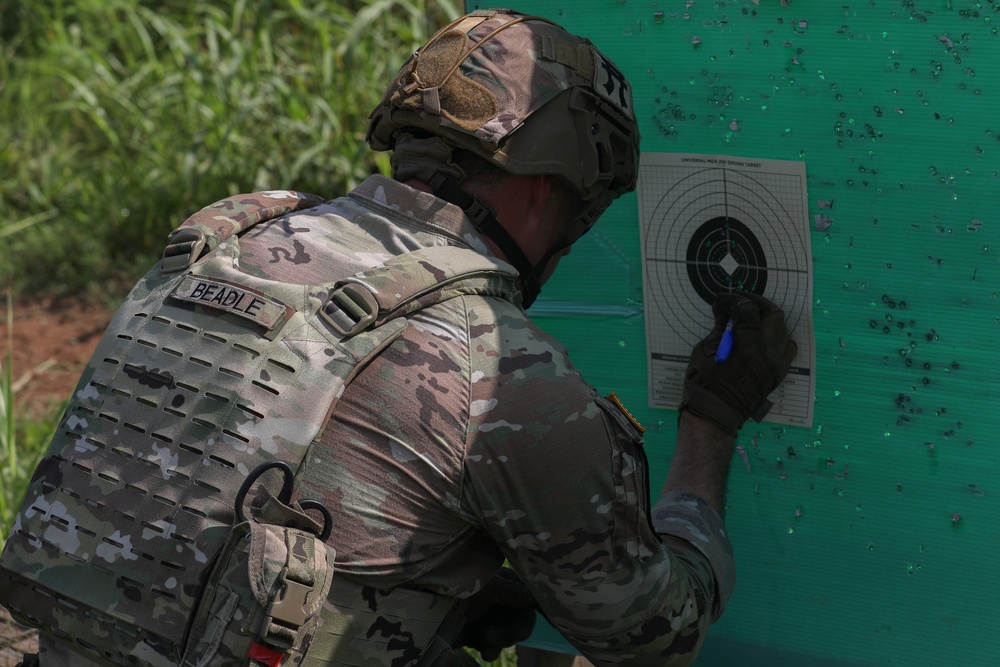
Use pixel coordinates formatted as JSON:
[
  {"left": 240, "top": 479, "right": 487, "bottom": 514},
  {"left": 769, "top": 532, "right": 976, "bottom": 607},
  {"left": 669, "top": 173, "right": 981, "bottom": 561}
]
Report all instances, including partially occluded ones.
[{"left": 468, "top": 0, "right": 1000, "bottom": 667}]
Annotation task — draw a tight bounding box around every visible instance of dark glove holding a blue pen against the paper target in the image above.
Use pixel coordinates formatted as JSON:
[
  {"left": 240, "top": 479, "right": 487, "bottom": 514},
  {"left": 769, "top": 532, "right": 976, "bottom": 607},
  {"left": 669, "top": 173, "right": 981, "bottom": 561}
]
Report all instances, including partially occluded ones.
[{"left": 679, "top": 292, "right": 798, "bottom": 435}]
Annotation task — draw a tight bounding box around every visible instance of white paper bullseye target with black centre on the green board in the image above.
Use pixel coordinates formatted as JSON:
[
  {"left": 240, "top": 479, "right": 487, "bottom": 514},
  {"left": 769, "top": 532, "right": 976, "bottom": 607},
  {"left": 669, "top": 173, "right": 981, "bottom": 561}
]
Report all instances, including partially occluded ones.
[{"left": 638, "top": 153, "right": 816, "bottom": 425}]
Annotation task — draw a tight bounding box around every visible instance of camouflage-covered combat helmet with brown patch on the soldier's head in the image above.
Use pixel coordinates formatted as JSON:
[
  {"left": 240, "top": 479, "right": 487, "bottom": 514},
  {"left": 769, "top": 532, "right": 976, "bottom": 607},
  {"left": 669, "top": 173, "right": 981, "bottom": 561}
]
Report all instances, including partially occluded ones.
[{"left": 367, "top": 9, "right": 639, "bottom": 226}]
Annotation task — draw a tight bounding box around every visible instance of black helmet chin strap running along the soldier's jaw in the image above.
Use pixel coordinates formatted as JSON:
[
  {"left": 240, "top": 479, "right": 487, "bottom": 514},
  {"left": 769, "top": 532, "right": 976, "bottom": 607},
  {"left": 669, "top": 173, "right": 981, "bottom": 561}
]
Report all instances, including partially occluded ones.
[{"left": 428, "top": 173, "right": 544, "bottom": 309}]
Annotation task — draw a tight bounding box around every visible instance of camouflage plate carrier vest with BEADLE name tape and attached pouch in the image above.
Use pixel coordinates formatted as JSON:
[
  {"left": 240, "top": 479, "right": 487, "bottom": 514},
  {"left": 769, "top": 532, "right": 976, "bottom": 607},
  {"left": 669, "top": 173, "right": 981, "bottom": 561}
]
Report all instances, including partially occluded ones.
[{"left": 0, "top": 192, "right": 515, "bottom": 667}]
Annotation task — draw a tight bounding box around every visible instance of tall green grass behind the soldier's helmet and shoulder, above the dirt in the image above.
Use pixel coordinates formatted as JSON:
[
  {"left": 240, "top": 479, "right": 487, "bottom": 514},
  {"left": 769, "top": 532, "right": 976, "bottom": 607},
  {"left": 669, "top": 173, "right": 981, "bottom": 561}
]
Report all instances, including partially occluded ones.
[{"left": 0, "top": 0, "right": 461, "bottom": 294}]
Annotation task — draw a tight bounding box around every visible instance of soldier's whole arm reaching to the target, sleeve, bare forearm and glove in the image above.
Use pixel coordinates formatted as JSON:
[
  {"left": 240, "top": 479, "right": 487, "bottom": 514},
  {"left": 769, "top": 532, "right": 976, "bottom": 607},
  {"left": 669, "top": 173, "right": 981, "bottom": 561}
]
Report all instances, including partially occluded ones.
[{"left": 467, "top": 295, "right": 795, "bottom": 667}]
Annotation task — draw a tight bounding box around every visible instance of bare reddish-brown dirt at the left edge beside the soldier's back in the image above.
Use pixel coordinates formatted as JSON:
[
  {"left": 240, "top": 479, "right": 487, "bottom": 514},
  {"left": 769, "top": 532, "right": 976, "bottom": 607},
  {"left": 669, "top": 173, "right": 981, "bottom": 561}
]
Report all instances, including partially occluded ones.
[{"left": 0, "top": 299, "right": 112, "bottom": 667}]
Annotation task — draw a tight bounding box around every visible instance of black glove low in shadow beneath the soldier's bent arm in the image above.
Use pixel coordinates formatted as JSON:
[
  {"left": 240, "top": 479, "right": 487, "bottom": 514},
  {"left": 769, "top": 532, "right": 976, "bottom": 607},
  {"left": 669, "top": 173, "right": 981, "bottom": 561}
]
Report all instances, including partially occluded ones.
[{"left": 455, "top": 568, "right": 536, "bottom": 662}]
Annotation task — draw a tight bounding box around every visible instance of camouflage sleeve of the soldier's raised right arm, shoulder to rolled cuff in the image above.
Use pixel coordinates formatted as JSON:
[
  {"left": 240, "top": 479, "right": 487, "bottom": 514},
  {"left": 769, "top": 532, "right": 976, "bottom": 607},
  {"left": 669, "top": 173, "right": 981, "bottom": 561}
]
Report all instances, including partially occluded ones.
[{"left": 463, "top": 300, "right": 734, "bottom": 665}]
